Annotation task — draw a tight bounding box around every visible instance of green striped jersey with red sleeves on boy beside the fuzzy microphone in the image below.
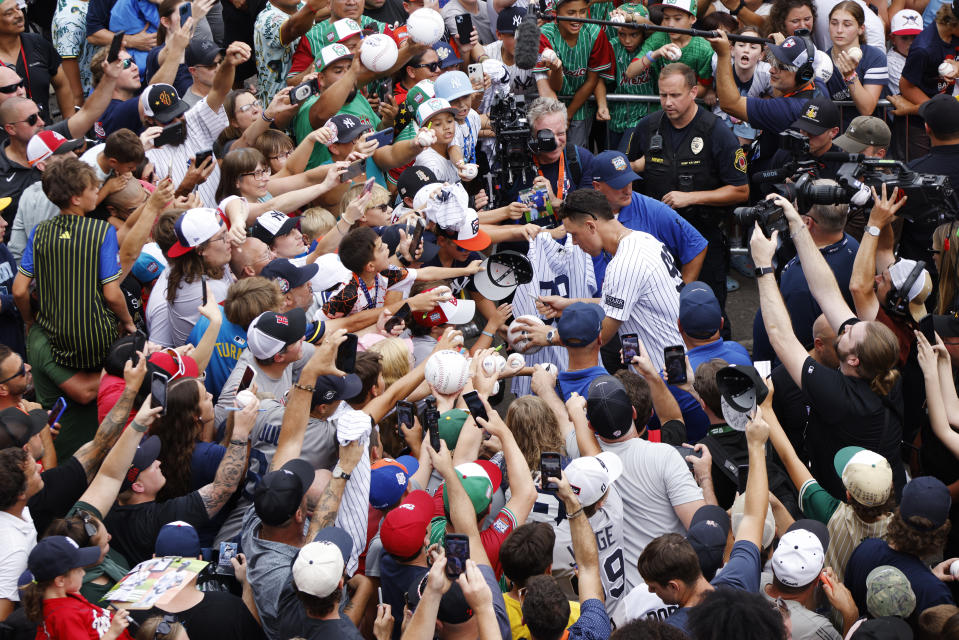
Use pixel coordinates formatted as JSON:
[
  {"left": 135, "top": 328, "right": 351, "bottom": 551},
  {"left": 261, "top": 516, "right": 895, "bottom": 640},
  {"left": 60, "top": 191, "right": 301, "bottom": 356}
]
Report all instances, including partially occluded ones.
[{"left": 533, "top": 22, "right": 616, "bottom": 120}]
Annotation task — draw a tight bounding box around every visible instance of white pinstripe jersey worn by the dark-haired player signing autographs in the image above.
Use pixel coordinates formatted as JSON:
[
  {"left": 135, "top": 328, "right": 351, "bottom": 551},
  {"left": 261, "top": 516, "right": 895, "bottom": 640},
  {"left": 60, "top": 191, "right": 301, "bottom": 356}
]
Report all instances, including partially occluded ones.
[{"left": 602, "top": 231, "right": 683, "bottom": 369}]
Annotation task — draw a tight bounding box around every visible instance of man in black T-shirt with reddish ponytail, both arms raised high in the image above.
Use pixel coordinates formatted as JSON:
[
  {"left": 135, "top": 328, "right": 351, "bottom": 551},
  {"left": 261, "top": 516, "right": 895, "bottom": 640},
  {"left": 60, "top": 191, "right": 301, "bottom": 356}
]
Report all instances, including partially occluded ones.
[{"left": 750, "top": 195, "right": 906, "bottom": 499}]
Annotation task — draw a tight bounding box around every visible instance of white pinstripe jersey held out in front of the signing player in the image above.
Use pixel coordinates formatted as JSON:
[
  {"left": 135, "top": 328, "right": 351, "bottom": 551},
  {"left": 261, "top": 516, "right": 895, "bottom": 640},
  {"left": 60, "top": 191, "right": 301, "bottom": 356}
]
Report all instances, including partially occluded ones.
[{"left": 512, "top": 233, "right": 592, "bottom": 396}]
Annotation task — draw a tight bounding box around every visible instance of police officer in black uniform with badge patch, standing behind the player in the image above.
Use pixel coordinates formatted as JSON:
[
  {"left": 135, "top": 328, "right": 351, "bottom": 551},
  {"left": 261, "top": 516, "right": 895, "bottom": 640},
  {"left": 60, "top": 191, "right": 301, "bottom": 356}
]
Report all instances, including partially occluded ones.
[{"left": 629, "top": 62, "right": 749, "bottom": 327}]
